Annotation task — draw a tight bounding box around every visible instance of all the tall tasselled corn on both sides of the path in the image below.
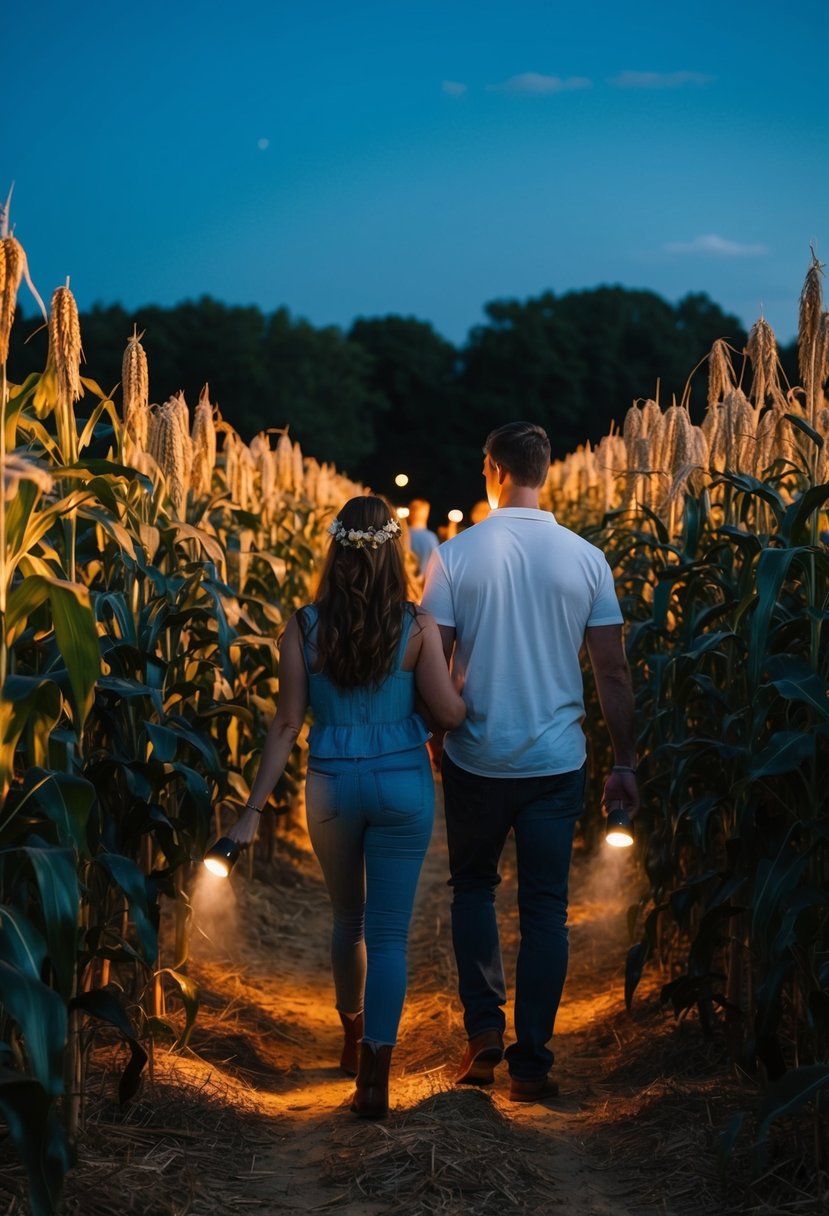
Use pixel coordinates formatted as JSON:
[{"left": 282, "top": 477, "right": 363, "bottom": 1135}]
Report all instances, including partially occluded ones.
[{"left": 0, "top": 211, "right": 829, "bottom": 1216}]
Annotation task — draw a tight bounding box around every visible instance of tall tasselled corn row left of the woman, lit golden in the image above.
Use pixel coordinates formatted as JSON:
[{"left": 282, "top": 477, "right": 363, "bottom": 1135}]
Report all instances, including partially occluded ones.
[{"left": 0, "top": 221, "right": 361, "bottom": 1216}]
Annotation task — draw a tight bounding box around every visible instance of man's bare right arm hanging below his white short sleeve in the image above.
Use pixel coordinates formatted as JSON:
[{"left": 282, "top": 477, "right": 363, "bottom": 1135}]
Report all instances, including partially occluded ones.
[{"left": 585, "top": 625, "right": 639, "bottom": 815}]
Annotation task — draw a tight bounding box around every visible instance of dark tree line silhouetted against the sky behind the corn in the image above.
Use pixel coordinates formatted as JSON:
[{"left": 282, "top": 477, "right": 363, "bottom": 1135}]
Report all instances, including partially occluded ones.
[{"left": 10, "top": 287, "right": 795, "bottom": 522}]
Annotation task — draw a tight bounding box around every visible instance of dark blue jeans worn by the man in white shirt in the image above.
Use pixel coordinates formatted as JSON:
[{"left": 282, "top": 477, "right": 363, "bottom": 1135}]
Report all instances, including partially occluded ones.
[{"left": 442, "top": 755, "right": 585, "bottom": 1081}]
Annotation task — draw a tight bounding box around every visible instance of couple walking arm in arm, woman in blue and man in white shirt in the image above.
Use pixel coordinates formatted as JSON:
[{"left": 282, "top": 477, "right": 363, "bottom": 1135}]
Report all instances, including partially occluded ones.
[{"left": 231, "top": 422, "right": 638, "bottom": 1118}]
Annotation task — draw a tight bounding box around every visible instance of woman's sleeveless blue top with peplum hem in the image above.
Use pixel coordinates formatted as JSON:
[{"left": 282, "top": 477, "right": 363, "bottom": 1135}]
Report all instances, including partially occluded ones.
[{"left": 301, "top": 604, "right": 429, "bottom": 760}]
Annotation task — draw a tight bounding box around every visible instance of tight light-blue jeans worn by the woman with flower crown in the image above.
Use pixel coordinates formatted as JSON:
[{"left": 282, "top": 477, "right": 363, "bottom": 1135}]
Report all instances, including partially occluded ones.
[{"left": 305, "top": 748, "right": 435, "bottom": 1045}]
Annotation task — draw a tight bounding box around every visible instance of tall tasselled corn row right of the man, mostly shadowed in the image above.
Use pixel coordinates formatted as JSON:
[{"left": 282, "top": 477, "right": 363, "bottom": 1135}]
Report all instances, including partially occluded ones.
[{"left": 547, "top": 259, "right": 829, "bottom": 1169}]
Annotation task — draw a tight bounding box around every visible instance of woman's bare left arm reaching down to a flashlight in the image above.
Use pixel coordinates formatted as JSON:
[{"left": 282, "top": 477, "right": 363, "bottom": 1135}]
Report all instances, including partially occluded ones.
[{"left": 227, "top": 614, "right": 308, "bottom": 845}]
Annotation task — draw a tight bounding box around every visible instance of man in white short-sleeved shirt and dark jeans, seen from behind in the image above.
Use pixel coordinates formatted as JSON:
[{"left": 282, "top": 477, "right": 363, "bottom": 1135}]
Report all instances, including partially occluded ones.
[{"left": 423, "top": 422, "right": 638, "bottom": 1102}]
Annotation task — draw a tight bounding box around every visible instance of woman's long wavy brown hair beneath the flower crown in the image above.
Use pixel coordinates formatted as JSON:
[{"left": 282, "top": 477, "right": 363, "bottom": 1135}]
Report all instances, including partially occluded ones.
[{"left": 308, "top": 495, "right": 415, "bottom": 688}]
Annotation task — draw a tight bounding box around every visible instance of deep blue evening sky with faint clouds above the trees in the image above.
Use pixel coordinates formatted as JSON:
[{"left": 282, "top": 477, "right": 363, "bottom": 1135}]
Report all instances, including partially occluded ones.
[{"left": 0, "top": 0, "right": 829, "bottom": 342}]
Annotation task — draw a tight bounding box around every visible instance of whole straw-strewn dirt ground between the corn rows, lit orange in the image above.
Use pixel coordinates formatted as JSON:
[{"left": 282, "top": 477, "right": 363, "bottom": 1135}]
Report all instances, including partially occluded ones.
[{"left": 0, "top": 834, "right": 829, "bottom": 1216}]
